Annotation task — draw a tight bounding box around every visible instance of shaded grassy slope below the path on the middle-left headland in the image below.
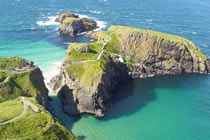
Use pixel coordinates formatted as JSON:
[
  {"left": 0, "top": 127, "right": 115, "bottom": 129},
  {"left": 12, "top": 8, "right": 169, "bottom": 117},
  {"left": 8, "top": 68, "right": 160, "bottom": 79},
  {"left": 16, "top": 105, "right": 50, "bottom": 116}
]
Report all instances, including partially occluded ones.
[{"left": 0, "top": 69, "right": 48, "bottom": 103}]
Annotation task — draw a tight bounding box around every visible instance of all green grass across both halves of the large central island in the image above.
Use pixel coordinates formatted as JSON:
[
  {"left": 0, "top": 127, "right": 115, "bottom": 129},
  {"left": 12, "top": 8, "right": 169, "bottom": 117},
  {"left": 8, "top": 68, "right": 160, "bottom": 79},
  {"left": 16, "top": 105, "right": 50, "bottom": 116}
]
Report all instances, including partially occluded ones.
[{"left": 65, "top": 26, "right": 207, "bottom": 90}]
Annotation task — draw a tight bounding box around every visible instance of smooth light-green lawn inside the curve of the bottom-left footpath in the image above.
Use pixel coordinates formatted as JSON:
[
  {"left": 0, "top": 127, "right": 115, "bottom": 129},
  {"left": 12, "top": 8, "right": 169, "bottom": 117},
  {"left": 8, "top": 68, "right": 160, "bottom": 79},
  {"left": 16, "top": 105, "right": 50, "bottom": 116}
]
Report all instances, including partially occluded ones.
[{"left": 0, "top": 99, "right": 23, "bottom": 123}]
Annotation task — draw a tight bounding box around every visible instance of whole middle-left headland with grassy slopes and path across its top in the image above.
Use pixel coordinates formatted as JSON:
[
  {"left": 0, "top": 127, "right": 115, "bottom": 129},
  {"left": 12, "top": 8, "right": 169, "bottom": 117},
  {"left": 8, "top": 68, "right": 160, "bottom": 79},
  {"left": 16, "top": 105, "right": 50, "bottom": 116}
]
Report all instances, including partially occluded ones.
[{"left": 0, "top": 57, "right": 49, "bottom": 106}]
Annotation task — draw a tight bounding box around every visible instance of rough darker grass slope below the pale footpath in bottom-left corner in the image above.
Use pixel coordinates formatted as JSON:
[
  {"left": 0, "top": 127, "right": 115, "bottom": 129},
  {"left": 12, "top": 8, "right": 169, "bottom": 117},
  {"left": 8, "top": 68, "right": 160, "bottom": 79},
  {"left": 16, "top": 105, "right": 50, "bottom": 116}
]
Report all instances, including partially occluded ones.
[{"left": 0, "top": 98, "right": 76, "bottom": 140}]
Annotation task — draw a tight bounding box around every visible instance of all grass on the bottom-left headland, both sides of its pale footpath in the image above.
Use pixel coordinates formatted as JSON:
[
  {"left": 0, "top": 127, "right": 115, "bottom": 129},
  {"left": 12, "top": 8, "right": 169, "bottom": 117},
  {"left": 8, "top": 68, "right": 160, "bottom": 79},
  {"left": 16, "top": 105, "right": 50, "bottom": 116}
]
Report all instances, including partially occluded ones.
[{"left": 0, "top": 98, "right": 76, "bottom": 140}]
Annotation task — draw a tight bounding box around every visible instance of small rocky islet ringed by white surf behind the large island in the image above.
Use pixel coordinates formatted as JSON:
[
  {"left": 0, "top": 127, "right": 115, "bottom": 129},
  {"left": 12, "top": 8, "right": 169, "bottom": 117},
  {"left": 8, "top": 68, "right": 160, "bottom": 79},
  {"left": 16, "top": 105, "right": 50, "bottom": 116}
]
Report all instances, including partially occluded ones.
[{"left": 55, "top": 12, "right": 98, "bottom": 36}]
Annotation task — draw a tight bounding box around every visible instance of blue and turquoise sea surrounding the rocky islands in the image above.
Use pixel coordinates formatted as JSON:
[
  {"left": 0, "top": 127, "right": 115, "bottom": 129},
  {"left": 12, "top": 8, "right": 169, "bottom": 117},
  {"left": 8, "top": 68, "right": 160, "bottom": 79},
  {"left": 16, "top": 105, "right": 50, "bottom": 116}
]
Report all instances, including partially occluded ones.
[{"left": 0, "top": 0, "right": 210, "bottom": 140}]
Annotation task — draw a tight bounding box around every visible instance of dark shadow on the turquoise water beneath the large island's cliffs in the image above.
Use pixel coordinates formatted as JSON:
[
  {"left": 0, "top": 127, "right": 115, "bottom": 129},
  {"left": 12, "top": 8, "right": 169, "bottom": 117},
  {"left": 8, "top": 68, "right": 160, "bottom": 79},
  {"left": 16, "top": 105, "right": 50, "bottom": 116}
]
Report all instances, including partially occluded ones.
[{"left": 99, "top": 75, "right": 210, "bottom": 121}]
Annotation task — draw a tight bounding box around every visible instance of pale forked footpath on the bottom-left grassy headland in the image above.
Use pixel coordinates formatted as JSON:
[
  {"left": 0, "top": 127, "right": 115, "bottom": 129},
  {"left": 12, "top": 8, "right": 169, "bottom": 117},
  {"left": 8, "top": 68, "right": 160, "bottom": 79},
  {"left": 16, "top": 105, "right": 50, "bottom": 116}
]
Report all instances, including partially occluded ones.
[{"left": 0, "top": 97, "right": 40, "bottom": 126}]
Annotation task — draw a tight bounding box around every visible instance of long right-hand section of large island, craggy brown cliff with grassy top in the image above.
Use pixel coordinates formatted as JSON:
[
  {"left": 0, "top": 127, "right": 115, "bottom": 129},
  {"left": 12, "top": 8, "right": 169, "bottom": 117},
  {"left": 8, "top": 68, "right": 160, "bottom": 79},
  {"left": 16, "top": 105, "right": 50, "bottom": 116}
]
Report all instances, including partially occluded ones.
[{"left": 104, "top": 26, "right": 210, "bottom": 78}]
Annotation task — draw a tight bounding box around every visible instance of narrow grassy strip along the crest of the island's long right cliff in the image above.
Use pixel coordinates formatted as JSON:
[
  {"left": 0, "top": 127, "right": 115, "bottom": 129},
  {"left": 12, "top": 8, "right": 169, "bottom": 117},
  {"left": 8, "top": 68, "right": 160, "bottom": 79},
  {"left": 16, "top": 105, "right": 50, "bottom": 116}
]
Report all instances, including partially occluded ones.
[{"left": 96, "top": 26, "right": 207, "bottom": 60}]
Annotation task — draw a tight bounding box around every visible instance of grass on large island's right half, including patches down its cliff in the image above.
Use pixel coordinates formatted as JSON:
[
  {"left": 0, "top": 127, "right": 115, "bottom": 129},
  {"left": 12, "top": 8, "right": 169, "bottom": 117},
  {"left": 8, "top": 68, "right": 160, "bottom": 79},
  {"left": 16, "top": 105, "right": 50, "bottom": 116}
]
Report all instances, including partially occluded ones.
[{"left": 93, "top": 26, "right": 207, "bottom": 60}]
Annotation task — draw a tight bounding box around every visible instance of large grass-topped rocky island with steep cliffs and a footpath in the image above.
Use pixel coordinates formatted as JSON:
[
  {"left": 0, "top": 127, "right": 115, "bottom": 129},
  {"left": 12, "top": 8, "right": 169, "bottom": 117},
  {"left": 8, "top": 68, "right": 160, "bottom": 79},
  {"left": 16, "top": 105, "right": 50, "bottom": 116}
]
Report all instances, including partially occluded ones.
[{"left": 51, "top": 26, "right": 210, "bottom": 116}]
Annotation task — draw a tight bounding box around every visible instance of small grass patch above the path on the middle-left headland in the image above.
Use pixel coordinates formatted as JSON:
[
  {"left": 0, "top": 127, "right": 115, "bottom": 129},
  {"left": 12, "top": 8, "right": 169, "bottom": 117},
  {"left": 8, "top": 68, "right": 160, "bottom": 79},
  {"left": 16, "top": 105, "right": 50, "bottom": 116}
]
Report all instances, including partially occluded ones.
[{"left": 0, "top": 57, "right": 24, "bottom": 69}]
